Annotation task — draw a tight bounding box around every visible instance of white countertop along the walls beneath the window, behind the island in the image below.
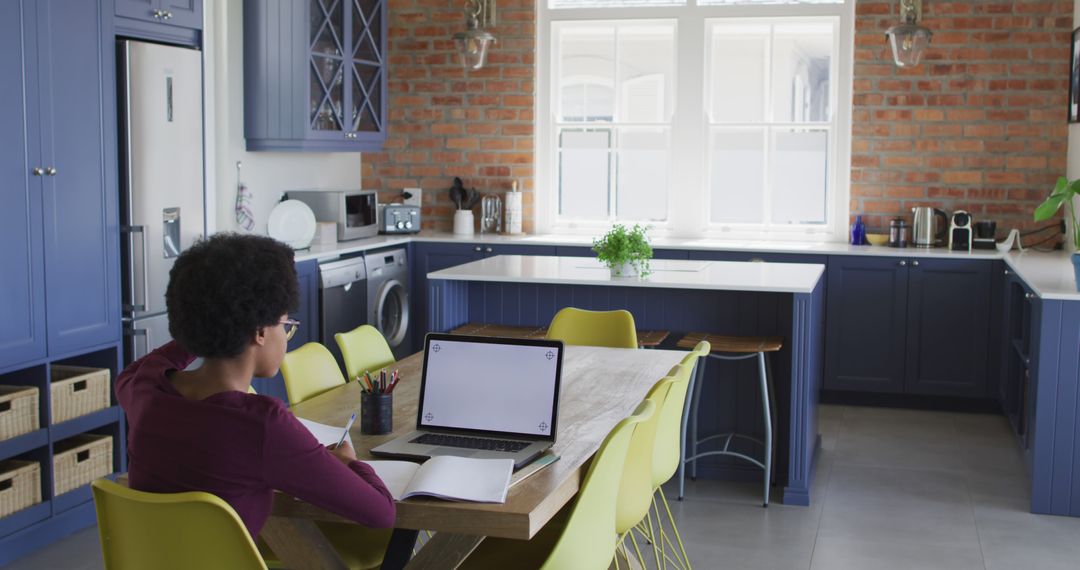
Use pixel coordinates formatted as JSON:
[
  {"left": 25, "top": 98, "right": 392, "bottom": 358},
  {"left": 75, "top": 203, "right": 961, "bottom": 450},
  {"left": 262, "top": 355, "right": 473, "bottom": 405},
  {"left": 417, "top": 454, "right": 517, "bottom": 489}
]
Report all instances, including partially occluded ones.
[{"left": 287, "top": 231, "right": 1080, "bottom": 301}]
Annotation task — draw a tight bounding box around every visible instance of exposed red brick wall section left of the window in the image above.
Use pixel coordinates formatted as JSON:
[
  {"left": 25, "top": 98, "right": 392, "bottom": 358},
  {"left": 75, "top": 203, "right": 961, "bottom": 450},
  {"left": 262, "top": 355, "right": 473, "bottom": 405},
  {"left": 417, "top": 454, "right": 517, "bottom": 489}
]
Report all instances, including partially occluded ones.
[{"left": 361, "top": 0, "right": 536, "bottom": 231}]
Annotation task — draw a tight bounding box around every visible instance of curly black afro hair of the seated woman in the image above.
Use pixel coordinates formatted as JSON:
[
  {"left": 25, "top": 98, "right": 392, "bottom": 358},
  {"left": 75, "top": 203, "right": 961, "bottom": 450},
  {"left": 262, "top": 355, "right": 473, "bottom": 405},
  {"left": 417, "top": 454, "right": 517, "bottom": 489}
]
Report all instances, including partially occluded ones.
[{"left": 165, "top": 233, "right": 300, "bottom": 358}]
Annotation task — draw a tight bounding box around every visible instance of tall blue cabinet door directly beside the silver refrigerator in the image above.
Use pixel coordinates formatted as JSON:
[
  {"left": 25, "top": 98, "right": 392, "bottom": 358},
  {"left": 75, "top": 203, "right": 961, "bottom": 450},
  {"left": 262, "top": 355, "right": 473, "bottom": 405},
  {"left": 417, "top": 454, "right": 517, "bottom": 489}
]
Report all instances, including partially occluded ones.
[{"left": 34, "top": 0, "right": 120, "bottom": 356}]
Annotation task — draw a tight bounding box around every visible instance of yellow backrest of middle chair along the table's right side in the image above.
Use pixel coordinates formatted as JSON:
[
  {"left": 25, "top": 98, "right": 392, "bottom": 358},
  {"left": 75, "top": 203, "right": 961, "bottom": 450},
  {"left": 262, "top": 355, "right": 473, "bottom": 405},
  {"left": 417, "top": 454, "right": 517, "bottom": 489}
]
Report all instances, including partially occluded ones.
[{"left": 615, "top": 377, "right": 676, "bottom": 534}]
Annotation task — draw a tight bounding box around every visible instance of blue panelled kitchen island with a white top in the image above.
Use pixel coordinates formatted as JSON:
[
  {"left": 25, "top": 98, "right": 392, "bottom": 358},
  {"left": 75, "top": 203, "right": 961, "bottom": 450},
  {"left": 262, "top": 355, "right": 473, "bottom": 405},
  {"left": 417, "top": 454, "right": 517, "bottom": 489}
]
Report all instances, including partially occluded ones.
[{"left": 427, "top": 255, "right": 825, "bottom": 505}]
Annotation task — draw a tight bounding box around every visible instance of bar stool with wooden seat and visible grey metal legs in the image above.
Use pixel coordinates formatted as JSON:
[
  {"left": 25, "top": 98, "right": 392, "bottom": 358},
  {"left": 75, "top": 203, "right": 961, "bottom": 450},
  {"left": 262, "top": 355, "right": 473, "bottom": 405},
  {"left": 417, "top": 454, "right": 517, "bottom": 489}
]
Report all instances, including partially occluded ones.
[{"left": 677, "top": 333, "right": 784, "bottom": 506}]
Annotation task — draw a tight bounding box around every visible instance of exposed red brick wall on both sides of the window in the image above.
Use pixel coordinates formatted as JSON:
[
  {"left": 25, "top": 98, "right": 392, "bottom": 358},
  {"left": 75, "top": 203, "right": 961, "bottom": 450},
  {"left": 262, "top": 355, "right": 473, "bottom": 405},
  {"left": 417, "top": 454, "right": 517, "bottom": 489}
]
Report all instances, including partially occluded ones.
[{"left": 362, "top": 0, "right": 1072, "bottom": 233}]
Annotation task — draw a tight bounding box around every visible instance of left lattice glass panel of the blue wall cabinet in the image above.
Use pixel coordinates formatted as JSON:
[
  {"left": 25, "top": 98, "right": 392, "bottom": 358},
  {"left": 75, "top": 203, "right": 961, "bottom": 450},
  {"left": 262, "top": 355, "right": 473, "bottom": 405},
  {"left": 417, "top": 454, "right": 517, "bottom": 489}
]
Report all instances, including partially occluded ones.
[{"left": 307, "top": 0, "right": 351, "bottom": 140}]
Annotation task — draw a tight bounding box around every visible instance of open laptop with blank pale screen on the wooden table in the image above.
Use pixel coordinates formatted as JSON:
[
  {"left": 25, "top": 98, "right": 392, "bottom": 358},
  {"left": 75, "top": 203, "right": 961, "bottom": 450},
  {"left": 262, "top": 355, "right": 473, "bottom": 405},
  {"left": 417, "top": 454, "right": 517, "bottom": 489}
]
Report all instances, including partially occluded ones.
[{"left": 372, "top": 333, "right": 563, "bottom": 469}]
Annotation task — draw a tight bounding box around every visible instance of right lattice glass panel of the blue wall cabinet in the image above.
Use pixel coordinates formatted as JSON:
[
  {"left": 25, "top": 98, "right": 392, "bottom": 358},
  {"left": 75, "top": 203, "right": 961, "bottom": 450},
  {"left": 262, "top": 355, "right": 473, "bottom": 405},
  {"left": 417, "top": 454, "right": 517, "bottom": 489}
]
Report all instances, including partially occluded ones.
[{"left": 348, "top": 0, "right": 387, "bottom": 140}]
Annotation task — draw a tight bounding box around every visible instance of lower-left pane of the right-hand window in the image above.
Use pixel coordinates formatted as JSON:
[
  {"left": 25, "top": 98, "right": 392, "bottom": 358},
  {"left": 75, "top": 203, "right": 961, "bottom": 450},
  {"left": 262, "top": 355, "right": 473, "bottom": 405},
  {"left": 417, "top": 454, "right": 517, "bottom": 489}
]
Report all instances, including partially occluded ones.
[{"left": 708, "top": 128, "right": 765, "bottom": 223}]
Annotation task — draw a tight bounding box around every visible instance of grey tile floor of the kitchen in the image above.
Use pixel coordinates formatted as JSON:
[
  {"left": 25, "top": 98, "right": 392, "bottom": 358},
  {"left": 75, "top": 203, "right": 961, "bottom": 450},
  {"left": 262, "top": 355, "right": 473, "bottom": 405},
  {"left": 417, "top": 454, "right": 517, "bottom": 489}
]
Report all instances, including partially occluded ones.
[{"left": 8, "top": 406, "right": 1080, "bottom": 570}]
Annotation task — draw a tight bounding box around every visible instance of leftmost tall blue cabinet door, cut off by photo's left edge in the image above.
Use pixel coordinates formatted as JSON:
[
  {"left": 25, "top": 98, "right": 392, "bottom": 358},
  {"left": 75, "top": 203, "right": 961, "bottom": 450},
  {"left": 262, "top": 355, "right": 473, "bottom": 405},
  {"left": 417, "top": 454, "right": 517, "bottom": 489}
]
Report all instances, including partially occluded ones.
[{"left": 0, "top": 2, "right": 45, "bottom": 369}]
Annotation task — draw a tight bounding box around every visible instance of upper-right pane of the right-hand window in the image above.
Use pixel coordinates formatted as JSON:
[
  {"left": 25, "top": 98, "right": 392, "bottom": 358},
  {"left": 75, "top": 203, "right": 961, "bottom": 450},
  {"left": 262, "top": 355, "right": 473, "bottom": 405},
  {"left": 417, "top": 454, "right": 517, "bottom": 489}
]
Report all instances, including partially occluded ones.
[{"left": 772, "top": 23, "right": 833, "bottom": 123}]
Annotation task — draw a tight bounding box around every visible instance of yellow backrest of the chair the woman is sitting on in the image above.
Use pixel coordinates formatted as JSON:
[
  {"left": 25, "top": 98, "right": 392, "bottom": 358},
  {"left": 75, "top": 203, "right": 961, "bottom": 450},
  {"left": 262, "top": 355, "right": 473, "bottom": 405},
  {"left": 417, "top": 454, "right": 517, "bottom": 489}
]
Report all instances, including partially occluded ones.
[{"left": 92, "top": 479, "right": 266, "bottom": 570}]
